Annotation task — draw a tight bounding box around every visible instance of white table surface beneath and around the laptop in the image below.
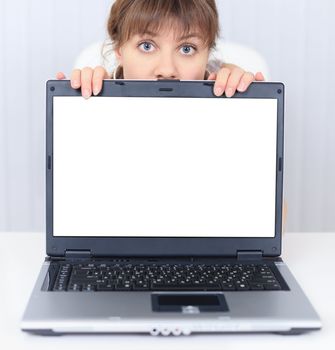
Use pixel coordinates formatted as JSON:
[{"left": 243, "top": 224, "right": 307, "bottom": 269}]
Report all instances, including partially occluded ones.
[{"left": 0, "top": 232, "right": 335, "bottom": 350}]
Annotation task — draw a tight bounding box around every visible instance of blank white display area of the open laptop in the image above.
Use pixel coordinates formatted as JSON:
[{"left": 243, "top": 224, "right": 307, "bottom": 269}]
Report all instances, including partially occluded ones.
[{"left": 53, "top": 96, "right": 277, "bottom": 237}]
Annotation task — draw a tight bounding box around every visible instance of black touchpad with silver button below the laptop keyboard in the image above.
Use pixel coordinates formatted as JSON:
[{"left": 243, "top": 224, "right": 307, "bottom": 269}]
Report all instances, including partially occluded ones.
[{"left": 151, "top": 293, "right": 229, "bottom": 314}]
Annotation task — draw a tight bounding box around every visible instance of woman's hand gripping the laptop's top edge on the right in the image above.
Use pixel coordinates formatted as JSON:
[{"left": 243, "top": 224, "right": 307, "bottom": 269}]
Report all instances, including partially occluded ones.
[{"left": 208, "top": 63, "right": 264, "bottom": 97}]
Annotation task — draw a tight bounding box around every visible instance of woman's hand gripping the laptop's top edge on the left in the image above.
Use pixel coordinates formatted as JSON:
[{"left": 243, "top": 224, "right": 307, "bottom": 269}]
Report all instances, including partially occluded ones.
[{"left": 56, "top": 66, "right": 109, "bottom": 98}]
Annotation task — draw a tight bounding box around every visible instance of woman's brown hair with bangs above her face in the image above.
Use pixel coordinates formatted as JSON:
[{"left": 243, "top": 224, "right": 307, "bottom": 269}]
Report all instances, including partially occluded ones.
[{"left": 107, "top": 0, "right": 219, "bottom": 49}]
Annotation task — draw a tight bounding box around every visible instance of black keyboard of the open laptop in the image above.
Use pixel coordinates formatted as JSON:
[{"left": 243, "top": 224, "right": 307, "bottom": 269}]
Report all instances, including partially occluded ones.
[{"left": 49, "top": 262, "right": 288, "bottom": 292}]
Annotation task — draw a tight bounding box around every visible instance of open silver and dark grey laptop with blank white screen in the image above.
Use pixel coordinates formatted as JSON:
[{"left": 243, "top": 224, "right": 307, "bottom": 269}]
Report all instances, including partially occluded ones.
[{"left": 21, "top": 80, "right": 321, "bottom": 335}]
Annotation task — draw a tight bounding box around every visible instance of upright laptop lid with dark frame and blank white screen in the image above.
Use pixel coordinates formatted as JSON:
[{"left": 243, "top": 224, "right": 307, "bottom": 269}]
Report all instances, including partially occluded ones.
[{"left": 46, "top": 80, "right": 284, "bottom": 256}]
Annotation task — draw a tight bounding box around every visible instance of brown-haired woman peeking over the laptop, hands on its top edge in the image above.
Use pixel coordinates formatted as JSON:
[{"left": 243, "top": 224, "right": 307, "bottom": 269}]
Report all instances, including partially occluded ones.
[{"left": 56, "top": 0, "right": 264, "bottom": 98}]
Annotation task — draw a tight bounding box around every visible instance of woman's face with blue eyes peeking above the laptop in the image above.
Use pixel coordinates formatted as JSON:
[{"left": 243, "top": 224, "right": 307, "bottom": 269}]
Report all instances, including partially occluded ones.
[{"left": 115, "top": 24, "right": 209, "bottom": 80}]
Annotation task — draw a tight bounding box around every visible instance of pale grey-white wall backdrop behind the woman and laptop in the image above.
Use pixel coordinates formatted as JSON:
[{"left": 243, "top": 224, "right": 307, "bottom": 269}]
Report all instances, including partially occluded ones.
[{"left": 0, "top": 0, "right": 335, "bottom": 231}]
